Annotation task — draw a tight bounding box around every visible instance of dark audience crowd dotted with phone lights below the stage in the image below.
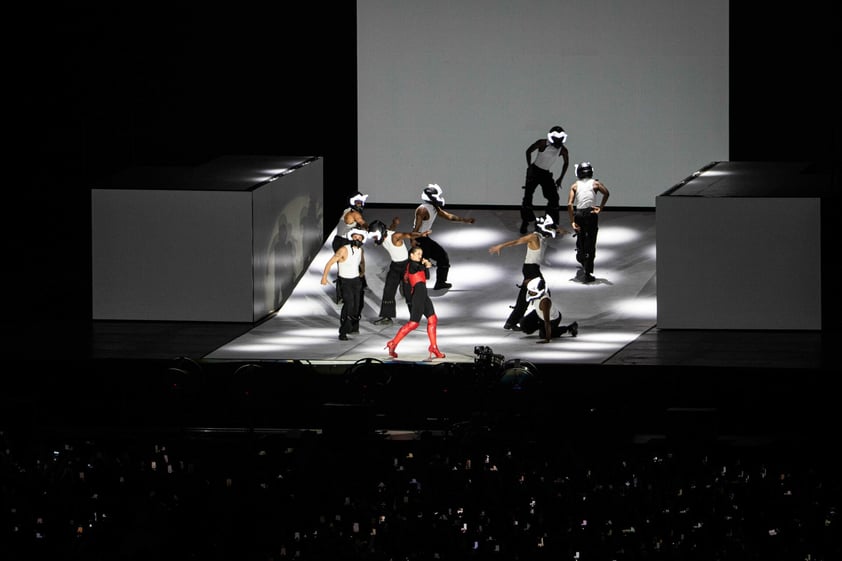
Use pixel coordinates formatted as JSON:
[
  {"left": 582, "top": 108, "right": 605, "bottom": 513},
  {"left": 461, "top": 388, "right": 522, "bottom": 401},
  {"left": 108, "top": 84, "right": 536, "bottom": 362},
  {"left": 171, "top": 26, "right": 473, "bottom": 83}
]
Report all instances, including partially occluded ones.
[{"left": 0, "top": 422, "right": 842, "bottom": 561}]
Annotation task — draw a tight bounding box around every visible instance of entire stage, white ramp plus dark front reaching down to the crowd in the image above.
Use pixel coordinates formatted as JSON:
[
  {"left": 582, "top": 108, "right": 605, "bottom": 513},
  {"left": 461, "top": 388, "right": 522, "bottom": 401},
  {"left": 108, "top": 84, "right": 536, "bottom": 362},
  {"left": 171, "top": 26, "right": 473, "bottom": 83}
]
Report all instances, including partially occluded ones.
[{"left": 4, "top": 208, "right": 828, "bottom": 438}]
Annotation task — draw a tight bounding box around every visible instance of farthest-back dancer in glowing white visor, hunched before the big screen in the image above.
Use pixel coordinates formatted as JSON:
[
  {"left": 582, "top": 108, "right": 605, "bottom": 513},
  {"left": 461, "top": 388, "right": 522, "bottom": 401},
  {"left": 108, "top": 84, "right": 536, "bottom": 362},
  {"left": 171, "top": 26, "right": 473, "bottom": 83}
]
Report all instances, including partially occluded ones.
[{"left": 520, "top": 126, "right": 570, "bottom": 234}]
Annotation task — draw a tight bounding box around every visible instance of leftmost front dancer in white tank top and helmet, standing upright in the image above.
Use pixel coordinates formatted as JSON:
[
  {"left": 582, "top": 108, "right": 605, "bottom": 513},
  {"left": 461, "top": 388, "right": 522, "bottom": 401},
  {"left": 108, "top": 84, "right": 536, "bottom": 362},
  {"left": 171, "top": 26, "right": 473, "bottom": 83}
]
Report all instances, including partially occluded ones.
[{"left": 322, "top": 229, "right": 368, "bottom": 341}]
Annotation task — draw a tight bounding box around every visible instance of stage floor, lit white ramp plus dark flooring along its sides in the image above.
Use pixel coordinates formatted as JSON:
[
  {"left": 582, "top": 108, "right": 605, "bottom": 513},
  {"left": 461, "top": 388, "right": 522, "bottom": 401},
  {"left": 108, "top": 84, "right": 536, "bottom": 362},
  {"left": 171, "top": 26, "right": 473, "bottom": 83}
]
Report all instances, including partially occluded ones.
[{"left": 79, "top": 208, "right": 838, "bottom": 371}]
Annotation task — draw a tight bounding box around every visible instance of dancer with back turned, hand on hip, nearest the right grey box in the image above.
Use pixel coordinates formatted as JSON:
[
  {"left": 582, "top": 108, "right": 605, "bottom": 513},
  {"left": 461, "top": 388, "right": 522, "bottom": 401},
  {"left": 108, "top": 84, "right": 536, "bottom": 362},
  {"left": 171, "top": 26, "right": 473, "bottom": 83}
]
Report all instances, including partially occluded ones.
[{"left": 567, "top": 162, "right": 609, "bottom": 283}]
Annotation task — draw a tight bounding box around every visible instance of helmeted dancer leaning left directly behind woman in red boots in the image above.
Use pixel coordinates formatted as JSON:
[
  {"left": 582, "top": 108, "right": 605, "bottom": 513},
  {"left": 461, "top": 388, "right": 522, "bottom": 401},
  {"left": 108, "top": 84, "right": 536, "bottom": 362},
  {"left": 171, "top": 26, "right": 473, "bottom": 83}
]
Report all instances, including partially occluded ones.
[{"left": 368, "top": 216, "right": 430, "bottom": 325}]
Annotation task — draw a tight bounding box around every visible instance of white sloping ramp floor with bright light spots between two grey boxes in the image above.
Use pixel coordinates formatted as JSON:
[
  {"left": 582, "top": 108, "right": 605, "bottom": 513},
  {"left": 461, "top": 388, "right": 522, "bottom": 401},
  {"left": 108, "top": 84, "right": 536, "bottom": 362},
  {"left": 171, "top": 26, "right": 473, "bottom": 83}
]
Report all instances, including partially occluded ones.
[{"left": 204, "top": 208, "right": 657, "bottom": 365}]
